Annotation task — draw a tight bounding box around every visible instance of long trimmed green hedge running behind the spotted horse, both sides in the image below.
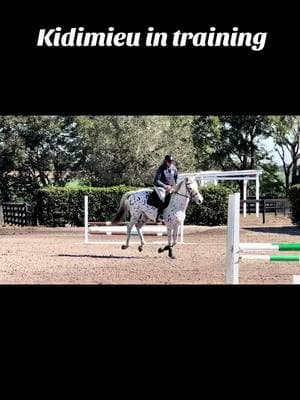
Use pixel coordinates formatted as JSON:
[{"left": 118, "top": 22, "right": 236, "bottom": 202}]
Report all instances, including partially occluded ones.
[{"left": 37, "top": 186, "right": 231, "bottom": 227}]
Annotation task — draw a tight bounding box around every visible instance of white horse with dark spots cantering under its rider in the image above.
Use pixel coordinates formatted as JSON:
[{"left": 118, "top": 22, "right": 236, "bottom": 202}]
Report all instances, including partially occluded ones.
[{"left": 113, "top": 177, "right": 203, "bottom": 258}]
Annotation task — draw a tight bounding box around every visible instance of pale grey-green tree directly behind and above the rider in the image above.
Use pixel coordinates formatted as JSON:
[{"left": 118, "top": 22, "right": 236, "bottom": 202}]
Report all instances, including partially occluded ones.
[{"left": 77, "top": 116, "right": 195, "bottom": 186}]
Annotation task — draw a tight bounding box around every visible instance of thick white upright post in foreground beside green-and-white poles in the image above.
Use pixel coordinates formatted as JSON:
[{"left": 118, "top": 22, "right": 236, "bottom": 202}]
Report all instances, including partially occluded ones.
[{"left": 225, "top": 193, "right": 240, "bottom": 284}]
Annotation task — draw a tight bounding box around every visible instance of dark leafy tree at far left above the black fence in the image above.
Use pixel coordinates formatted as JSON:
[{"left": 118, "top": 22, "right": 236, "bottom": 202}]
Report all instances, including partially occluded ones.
[{"left": 0, "top": 116, "right": 78, "bottom": 201}]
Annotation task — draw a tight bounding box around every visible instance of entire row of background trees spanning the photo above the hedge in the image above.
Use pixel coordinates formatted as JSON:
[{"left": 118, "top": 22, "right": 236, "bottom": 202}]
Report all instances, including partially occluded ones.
[{"left": 0, "top": 115, "right": 300, "bottom": 206}]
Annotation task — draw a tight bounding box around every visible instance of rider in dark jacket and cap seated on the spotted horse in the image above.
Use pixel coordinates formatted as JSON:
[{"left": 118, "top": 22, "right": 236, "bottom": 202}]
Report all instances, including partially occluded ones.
[{"left": 154, "top": 154, "right": 178, "bottom": 222}]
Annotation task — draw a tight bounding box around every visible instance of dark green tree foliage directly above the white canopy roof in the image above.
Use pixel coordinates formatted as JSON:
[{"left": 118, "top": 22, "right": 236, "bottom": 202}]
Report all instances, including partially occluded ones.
[{"left": 192, "top": 115, "right": 271, "bottom": 170}]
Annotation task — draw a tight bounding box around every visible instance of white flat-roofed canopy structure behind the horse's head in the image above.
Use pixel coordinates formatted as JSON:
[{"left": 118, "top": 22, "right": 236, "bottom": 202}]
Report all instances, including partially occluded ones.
[{"left": 179, "top": 169, "right": 263, "bottom": 217}]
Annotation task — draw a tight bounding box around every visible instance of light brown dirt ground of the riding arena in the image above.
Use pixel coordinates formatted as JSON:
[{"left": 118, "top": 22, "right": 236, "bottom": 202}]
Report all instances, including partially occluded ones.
[{"left": 0, "top": 215, "right": 300, "bottom": 284}]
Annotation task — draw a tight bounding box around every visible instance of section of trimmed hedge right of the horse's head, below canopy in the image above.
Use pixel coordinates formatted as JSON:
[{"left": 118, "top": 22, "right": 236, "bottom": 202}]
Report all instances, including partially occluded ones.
[{"left": 185, "top": 185, "right": 233, "bottom": 226}]
